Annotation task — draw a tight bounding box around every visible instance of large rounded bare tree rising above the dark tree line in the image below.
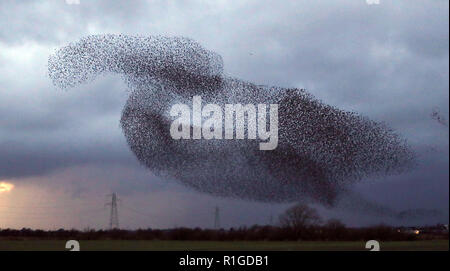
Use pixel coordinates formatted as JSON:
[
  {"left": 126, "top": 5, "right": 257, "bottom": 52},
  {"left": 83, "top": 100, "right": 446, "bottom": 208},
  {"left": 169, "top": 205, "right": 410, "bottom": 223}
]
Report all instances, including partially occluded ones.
[{"left": 280, "top": 203, "right": 321, "bottom": 229}]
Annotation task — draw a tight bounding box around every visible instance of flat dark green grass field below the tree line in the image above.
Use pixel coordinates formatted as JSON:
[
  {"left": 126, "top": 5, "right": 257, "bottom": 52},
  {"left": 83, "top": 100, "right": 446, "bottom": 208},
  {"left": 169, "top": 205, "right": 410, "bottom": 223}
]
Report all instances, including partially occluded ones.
[{"left": 0, "top": 240, "right": 449, "bottom": 251}]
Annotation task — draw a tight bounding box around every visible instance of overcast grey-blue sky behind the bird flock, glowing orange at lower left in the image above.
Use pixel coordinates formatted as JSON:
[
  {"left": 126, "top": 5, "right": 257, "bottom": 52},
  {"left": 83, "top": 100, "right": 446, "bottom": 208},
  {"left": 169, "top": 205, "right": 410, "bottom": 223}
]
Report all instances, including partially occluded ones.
[{"left": 0, "top": 0, "right": 449, "bottom": 229}]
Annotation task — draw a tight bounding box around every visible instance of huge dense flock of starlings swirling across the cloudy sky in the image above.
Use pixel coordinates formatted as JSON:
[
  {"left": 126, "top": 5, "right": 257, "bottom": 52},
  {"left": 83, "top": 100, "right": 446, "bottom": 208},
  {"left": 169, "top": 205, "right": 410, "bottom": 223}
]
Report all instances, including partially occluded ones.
[{"left": 48, "top": 34, "right": 415, "bottom": 206}]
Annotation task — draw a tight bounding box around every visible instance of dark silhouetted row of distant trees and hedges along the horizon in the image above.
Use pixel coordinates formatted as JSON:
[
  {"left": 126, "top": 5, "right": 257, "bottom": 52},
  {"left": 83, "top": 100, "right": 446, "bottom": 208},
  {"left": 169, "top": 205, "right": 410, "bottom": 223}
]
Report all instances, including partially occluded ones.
[{"left": 0, "top": 204, "right": 448, "bottom": 241}]
